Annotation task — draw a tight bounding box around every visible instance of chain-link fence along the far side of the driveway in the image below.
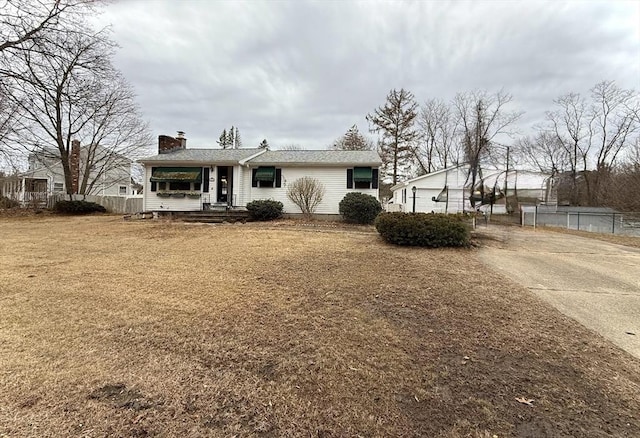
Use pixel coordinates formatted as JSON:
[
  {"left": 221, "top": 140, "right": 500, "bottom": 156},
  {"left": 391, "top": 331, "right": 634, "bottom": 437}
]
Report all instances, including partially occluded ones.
[{"left": 521, "top": 206, "right": 640, "bottom": 236}]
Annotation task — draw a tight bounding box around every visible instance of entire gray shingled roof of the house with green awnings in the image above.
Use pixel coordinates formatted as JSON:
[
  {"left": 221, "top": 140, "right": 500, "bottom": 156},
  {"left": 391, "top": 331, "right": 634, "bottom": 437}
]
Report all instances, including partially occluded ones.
[{"left": 138, "top": 148, "right": 382, "bottom": 167}]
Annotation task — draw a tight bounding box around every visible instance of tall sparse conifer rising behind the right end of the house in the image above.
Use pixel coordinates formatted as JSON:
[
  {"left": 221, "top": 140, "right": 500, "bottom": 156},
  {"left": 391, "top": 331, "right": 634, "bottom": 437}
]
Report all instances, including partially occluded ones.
[{"left": 367, "top": 88, "right": 420, "bottom": 184}]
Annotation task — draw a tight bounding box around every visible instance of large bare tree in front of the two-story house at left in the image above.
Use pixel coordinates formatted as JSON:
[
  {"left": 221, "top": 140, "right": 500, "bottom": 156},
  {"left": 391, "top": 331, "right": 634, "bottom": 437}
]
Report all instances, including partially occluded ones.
[{"left": 3, "top": 23, "right": 151, "bottom": 194}]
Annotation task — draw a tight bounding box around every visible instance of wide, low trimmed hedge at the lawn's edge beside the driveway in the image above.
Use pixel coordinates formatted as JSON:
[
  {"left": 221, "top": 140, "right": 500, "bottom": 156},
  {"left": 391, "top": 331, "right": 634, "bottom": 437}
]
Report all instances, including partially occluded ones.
[{"left": 375, "top": 213, "right": 470, "bottom": 248}]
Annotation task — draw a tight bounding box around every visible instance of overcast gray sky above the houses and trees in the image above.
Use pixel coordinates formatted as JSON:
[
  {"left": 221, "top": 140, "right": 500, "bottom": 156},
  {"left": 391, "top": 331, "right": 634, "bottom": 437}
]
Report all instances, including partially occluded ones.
[{"left": 100, "top": 0, "right": 640, "bottom": 149}]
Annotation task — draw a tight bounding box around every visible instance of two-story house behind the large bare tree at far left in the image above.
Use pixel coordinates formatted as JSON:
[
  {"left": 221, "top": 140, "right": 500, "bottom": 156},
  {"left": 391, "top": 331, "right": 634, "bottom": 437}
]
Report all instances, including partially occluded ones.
[{"left": 0, "top": 140, "right": 134, "bottom": 205}]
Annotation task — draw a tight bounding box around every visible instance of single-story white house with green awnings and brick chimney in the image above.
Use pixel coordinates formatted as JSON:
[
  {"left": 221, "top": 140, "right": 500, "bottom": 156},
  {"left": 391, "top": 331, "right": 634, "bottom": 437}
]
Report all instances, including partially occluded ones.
[{"left": 139, "top": 135, "right": 381, "bottom": 215}]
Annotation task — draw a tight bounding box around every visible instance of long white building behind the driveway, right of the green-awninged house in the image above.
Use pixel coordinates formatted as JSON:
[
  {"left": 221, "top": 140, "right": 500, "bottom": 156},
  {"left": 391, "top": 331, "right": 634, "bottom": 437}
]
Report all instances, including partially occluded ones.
[{"left": 387, "top": 165, "right": 556, "bottom": 213}]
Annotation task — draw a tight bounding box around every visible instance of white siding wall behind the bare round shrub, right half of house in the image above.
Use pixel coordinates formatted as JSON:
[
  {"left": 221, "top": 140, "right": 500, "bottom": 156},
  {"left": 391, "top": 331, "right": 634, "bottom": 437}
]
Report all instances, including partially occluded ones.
[{"left": 243, "top": 167, "right": 378, "bottom": 214}]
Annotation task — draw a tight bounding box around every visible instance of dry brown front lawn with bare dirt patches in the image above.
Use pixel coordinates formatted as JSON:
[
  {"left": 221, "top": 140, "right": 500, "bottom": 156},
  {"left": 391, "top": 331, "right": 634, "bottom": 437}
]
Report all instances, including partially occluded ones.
[{"left": 0, "top": 216, "right": 640, "bottom": 438}]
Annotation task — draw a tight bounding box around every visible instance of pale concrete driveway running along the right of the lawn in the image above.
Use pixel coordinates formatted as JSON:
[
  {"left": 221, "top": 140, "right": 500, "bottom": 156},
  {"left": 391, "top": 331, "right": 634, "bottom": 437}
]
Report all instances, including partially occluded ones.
[{"left": 478, "top": 225, "right": 640, "bottom": 358}]
